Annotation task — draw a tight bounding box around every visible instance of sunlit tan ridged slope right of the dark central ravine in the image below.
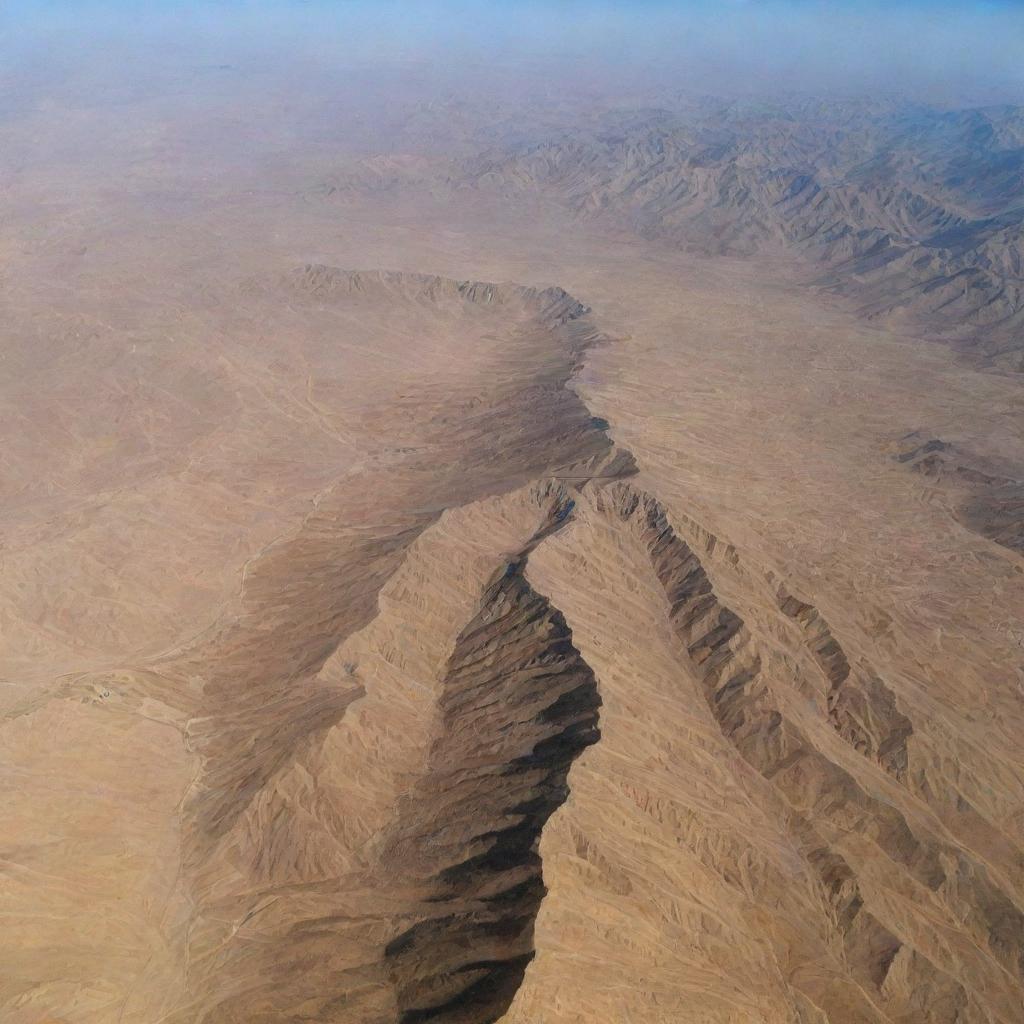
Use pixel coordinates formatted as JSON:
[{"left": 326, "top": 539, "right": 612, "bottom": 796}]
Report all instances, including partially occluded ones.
[{"left": 510, "top": 483, "right": 1024, "bottom": 1024}]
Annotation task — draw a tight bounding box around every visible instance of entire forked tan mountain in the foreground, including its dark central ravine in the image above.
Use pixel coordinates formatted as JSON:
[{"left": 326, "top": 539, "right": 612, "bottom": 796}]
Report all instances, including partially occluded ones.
[{"left": 172, "top": 460, "right": 1024, "bottom": 1024}]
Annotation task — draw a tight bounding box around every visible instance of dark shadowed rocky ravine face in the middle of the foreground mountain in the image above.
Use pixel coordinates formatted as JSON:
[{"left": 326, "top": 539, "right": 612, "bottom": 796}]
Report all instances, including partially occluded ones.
[{"left": 383, "top": 520, "right": 600, "bottom": 1024}]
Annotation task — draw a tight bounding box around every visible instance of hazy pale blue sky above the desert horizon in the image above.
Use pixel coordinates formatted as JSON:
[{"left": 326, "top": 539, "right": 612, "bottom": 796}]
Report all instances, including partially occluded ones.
[{"left": 0, "top": 0, "right": 1024, "bottom": 104}]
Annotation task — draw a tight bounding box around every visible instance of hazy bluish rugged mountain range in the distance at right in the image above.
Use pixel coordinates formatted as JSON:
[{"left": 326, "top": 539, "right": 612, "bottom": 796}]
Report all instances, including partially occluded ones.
[{"left": 329, "top": 99, "right": 1024, "bottom": 373}]
